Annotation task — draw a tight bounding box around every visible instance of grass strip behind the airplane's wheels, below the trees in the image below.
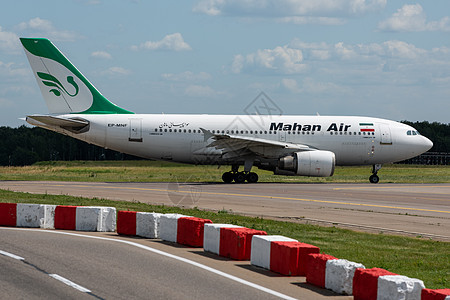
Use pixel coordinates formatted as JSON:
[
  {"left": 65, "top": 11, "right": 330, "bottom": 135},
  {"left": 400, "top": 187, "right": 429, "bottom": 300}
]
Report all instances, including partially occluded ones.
[{"left": 0, "top": 160, "right": 450, "bottom": 183}]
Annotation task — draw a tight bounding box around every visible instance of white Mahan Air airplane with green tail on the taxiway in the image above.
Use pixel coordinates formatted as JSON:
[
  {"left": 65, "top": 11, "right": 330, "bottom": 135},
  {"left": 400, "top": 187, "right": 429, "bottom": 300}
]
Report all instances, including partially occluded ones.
[{"left": 20, "top": 38, "right": 433, "bottom": 183}]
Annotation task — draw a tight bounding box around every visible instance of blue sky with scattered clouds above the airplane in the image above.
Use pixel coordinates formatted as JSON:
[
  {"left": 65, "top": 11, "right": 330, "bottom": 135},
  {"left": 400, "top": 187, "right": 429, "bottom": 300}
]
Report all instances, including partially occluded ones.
[{"left": 0, "top": 0, "right": 450, "bottom": 127}]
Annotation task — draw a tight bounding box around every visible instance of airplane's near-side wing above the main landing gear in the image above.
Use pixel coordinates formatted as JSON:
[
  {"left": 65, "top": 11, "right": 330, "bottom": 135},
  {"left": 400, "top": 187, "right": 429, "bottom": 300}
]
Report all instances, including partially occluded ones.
[{"left": 200, "top": 128, "right": 316, "bottom": 158}]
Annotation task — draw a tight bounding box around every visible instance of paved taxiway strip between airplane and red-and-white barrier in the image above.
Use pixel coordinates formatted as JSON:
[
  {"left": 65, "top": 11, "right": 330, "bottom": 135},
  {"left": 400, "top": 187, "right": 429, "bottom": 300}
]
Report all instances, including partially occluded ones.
[{"left": 0, "top": 181, "right": 450, "bottom": 241}]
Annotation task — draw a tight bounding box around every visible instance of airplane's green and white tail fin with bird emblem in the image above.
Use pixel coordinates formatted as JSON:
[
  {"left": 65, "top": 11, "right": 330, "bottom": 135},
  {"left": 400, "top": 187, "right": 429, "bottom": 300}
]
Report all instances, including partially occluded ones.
[{"left": 20, "top": 38, "right": 132, "bottom": 114}]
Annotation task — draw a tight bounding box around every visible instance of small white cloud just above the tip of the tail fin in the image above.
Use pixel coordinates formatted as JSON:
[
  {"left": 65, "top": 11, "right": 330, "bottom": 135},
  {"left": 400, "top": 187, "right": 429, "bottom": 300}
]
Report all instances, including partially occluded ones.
[{"left": 17, "top": 18, "right": 79, "bottom": 42}]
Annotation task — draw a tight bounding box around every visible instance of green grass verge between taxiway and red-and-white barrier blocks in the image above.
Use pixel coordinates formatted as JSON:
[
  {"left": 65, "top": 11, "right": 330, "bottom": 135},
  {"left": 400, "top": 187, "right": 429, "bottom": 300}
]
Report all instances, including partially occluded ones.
[{"left": 0, "top": 190, "right": 450, "bottom": 289}]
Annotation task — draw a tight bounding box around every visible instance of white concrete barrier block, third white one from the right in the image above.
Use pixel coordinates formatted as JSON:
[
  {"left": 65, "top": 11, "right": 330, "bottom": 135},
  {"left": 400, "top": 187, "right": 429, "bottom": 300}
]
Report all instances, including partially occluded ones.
[{"left": 250, "top": 235, "right": 297, "bottom": 270}]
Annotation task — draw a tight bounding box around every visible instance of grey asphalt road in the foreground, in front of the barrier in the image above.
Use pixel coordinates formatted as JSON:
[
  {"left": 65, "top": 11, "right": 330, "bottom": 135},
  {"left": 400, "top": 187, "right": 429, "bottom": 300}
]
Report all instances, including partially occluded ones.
[{"left": 0, "top": 227, "right": 352, "bottom": 299}]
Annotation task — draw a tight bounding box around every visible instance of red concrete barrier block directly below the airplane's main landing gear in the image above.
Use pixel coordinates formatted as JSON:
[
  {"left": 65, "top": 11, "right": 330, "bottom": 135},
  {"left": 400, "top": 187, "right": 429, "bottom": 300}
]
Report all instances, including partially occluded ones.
[{"left": 219, "top": 227, "right": 267, "bottom": 260}]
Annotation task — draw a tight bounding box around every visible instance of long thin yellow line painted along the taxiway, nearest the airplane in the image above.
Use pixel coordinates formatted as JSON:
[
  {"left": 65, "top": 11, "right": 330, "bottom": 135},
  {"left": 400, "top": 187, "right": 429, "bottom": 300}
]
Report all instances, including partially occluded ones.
[{"left": 60, "top": 185, "right": 450, "bottom": 214}]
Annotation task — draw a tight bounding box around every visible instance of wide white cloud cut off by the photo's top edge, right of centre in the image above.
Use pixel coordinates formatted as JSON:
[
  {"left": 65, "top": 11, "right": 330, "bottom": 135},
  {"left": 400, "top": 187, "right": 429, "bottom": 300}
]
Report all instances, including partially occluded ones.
[{"left": 193, "top": 0, "right": 387, "bottom": 25}]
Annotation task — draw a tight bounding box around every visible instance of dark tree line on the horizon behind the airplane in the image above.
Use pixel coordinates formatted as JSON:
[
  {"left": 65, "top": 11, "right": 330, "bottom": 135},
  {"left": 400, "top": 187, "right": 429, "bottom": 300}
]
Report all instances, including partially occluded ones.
[{"left": 0, "top": 121, "right": 450, "bottom": 166}]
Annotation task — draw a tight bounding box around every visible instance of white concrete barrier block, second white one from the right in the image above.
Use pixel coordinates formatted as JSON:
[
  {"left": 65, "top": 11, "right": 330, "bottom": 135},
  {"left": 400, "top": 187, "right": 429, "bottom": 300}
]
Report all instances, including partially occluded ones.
[{"left": 325, "top": 259, "right": 365, "bottom": 295}]
